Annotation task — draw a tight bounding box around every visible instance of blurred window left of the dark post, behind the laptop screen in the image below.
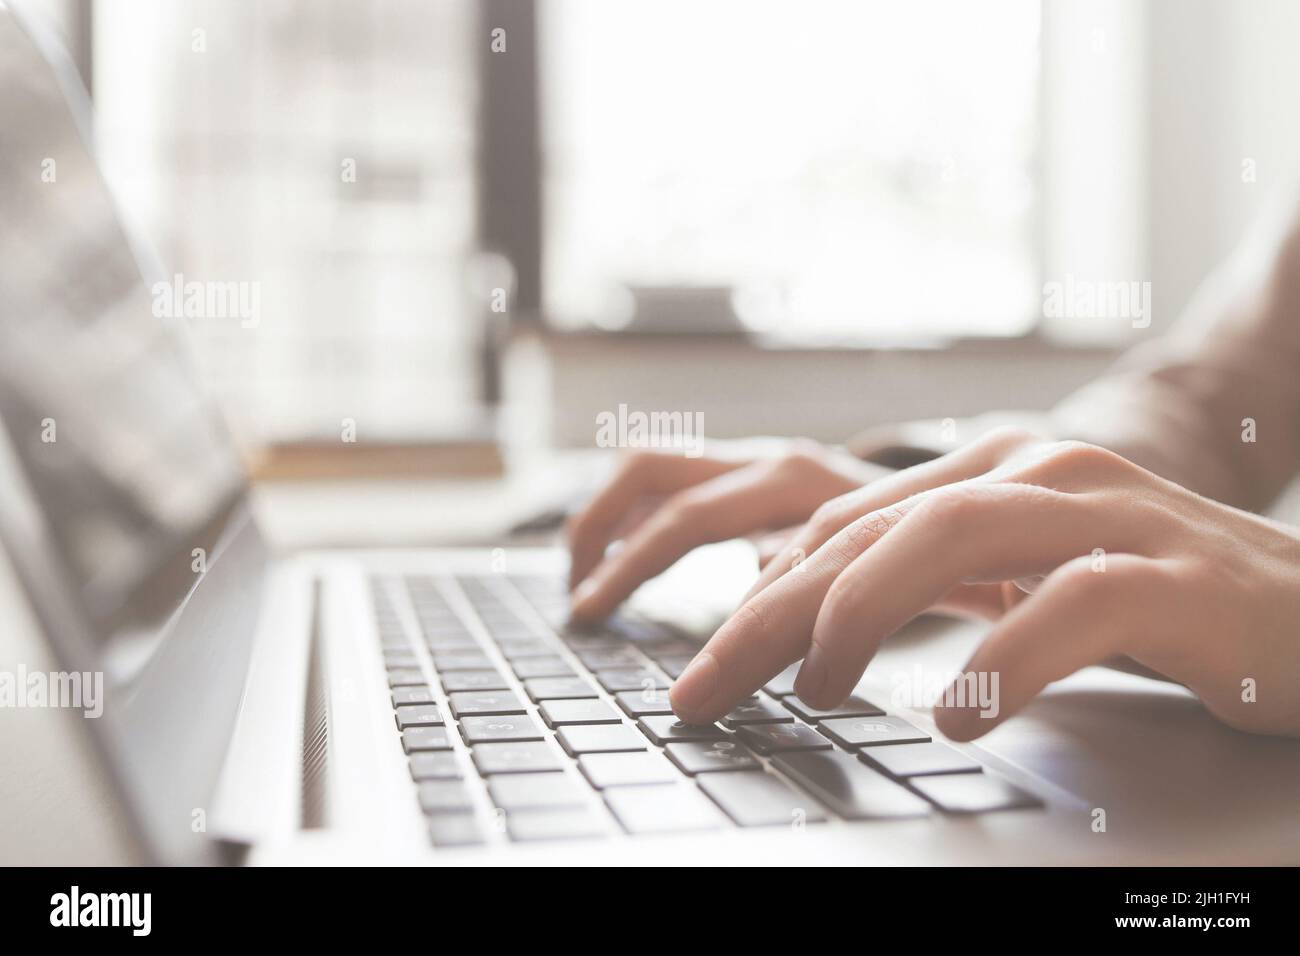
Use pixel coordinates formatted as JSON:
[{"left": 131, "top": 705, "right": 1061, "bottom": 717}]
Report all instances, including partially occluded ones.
[{"left": 94, "top": 0, "right": 478, "bottom": 438}]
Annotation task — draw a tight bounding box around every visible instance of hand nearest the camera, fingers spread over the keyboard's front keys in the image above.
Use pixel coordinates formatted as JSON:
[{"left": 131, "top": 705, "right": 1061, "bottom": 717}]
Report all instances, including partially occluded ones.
[{"left": 672, "top": 431, "right": 1300, "bottom": 740}]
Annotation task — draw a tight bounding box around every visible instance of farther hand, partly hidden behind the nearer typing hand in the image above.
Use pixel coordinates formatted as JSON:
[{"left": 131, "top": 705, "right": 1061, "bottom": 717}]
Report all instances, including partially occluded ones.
[{"left": 568, "top": 440, "right": 891, "bottom": 623}]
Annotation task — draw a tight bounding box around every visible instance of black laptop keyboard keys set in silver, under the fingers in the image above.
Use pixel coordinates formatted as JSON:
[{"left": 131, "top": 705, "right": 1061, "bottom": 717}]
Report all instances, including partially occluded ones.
[{"left": 372, "top": 575, "right": 1041, "bottom": 847}]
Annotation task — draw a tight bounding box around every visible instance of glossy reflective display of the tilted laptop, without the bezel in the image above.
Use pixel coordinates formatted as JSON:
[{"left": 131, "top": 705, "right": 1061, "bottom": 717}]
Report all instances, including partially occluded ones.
[{"left": 0, "top": 7, "right": 243, "bottom": 639}]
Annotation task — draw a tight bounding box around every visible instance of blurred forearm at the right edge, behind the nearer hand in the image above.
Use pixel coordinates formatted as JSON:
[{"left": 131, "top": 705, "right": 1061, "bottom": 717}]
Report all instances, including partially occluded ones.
[{"left": 1050, "top": 215, "right": 1300, "bottom": 510}]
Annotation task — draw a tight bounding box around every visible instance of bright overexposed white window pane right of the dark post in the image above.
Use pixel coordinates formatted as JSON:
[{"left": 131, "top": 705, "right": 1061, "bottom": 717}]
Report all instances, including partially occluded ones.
[{"left": 540, "top": 0, "right": 1040, "bottom": 342}]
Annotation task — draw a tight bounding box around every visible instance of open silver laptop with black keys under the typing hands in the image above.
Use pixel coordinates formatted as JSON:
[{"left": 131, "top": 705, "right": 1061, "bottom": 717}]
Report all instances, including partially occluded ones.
[{"left": 0, "top": 3, "right": 1300, "bottom": 865}]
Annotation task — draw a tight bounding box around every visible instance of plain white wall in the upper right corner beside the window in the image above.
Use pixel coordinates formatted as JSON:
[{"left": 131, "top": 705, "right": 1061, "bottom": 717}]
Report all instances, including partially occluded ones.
[{"left": 1149, "top": 0, "right": 1300, "bottom": 330}]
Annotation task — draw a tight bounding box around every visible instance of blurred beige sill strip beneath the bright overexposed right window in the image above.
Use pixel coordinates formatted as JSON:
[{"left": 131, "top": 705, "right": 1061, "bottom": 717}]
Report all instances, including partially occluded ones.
[{"left": 504, "top": 330, "right": 1118, "bottom": 447}]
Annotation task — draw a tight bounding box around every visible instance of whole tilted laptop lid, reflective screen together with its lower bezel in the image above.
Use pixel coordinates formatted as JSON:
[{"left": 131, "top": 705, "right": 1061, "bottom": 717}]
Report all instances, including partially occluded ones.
[{"left": 0, "top": 7, "right": 265, "bottom": 862}]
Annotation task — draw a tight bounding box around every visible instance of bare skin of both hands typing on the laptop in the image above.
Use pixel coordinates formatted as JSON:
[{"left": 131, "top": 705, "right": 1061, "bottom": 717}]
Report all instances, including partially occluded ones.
[{"left": 571, "top": 429, "right": 1300, "bottom": 740}]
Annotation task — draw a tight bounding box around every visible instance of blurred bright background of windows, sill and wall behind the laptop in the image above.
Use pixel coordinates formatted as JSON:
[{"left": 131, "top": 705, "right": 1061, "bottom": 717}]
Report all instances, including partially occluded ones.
[{"left": 17, "top": 0, "right": 1300, "bottom": 472}]
